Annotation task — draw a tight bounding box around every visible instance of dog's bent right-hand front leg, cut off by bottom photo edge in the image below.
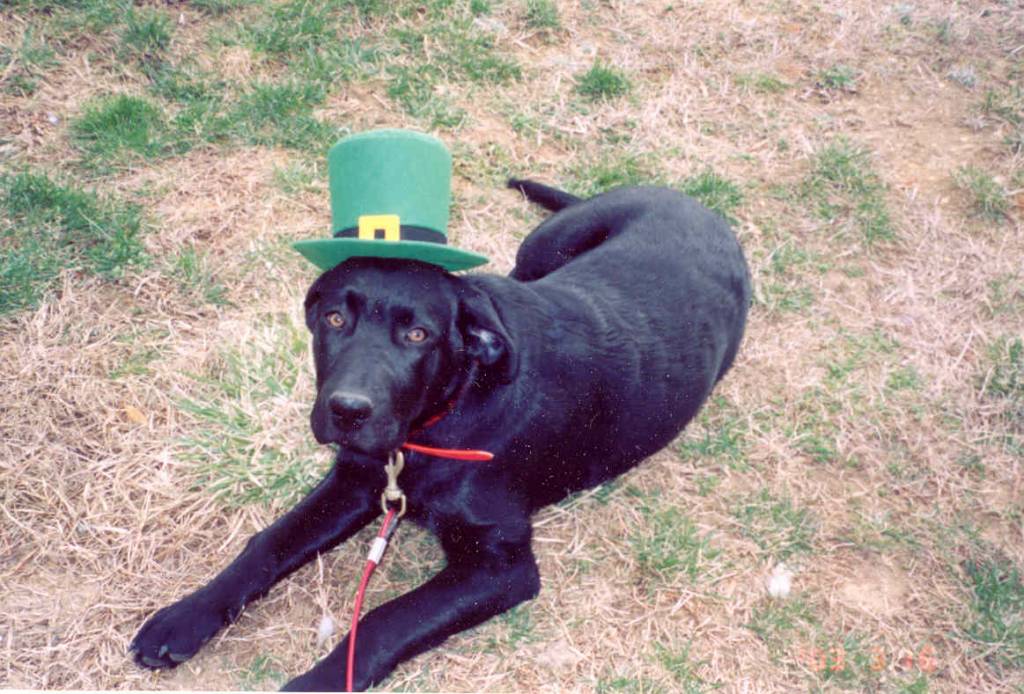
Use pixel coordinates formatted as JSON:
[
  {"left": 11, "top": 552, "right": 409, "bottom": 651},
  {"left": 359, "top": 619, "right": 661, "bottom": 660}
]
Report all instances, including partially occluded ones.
[{"left": 284, "top": 540, "right": 541, "bottom": 691}]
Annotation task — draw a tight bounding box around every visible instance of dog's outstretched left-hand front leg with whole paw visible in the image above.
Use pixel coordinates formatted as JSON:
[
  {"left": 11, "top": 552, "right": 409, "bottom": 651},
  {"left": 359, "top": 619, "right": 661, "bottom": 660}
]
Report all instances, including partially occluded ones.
[{"left": 130, "top": 463, "right": 384, "bottom": 667}]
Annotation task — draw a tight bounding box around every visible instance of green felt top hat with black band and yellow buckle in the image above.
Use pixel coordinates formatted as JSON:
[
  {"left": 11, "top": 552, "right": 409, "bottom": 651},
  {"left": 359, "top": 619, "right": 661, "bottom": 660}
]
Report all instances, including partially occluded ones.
[{"left": 292, "top": 130, "right": 487, "bottom": 270}]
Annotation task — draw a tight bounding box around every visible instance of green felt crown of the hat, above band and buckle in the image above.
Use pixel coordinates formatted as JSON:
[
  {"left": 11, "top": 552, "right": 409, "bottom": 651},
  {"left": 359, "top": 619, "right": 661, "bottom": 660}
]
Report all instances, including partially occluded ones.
[{"left": 328, "top": 130, "right": 452, "bottom": 236}]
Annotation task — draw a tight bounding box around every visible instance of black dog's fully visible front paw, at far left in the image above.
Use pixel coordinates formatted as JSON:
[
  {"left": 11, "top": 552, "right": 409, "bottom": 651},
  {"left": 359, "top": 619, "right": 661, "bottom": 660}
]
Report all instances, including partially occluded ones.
[{"left": 128, "top": 594, "right": 228, "bottom": 669}]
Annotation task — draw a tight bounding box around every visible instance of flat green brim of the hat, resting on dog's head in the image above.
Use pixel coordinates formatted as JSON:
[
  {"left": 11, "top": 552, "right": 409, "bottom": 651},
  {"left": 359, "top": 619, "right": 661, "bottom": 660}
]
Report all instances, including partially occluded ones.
[{"left": 292, "top": 238, "right": 487, "bottom": 272}]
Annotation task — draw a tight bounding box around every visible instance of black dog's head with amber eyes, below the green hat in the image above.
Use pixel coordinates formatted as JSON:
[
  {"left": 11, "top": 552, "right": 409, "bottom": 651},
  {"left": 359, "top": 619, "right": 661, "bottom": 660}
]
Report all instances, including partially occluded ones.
[{"left": 305, "top": 258, "right": 516, "bottom": 458}]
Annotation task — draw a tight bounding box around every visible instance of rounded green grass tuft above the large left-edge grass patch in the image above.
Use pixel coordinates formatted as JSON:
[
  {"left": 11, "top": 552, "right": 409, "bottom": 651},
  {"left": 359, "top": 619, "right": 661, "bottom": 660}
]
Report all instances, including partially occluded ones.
[{"left": 70, "top": 94, "right": 176, "bottom": 170}]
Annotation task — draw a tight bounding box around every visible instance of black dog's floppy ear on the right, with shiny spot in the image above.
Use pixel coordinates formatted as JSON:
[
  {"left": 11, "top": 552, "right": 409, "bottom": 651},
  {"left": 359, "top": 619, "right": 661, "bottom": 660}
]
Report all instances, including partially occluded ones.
[{"left": 457, "top": 284, "right": 519, "bottom": 383}]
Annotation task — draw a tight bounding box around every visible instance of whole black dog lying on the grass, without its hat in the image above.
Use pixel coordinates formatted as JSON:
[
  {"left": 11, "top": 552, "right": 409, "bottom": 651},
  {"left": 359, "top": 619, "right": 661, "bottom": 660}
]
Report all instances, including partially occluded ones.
[{"left": 131, "top": 181, "right": 751, "bottom": 690}]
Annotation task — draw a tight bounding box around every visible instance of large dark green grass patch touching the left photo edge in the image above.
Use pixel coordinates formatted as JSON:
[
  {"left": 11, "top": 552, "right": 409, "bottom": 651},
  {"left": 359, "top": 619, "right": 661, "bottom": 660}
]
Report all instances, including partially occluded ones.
[{"left": 0, "top": 172, "right": 146, "bottom": 313}]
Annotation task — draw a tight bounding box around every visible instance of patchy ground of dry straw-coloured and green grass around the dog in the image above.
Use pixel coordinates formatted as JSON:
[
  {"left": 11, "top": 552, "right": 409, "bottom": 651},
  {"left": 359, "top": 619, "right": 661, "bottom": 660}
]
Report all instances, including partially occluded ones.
[{"left": 0, "top": 0, "right": 1024, "bottom": 692}]
